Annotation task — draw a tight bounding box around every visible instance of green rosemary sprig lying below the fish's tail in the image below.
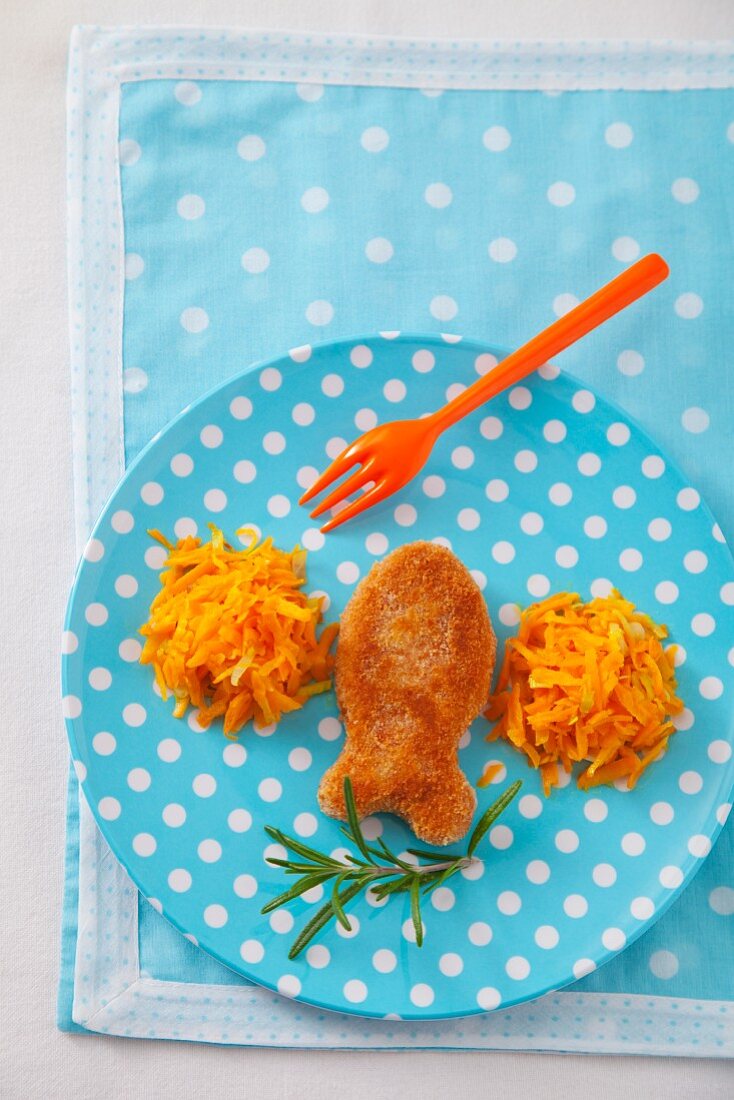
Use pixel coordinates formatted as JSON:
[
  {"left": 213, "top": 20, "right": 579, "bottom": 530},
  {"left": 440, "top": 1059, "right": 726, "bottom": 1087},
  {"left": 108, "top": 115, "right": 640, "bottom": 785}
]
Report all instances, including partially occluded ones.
[{"left": 261, "top": 777, "right": 522, "bottom": 959}]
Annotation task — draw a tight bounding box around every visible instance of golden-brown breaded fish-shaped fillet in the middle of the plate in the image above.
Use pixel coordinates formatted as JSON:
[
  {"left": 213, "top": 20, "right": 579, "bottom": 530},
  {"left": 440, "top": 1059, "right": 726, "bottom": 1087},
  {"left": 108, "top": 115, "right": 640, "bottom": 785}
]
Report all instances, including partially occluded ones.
[{"left": 318, "top": 542, "right": 496, "bottom": 845}]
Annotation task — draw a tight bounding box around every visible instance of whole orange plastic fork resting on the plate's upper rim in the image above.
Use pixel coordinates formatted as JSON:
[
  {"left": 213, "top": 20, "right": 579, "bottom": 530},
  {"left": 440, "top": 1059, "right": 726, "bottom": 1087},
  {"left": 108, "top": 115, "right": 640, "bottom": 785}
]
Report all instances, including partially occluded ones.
[{"left": 300, "top": 253, "right": 669, "bottom": 531}]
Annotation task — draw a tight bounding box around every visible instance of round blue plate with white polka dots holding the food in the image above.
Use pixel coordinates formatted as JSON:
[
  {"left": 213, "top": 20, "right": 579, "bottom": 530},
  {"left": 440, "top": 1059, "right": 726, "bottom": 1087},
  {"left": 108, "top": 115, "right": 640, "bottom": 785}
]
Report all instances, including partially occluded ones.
[{"left": 63, "top": 333, "right": 734, "bottom": 1019}]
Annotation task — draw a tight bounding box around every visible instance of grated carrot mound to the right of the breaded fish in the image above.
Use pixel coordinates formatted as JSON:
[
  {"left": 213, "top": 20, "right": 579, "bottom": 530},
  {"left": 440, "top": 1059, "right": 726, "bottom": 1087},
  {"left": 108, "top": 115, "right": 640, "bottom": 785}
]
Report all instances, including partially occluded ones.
[{"left": 485, "top": 589, "right": 683, "bottom": 794}]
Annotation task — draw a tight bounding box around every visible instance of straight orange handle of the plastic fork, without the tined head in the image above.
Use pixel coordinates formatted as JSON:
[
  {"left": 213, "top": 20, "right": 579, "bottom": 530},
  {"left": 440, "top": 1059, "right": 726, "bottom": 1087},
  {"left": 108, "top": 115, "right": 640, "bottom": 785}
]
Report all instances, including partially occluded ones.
[{"left": 430, "top": 252, "right": 669, "bottom": 436}]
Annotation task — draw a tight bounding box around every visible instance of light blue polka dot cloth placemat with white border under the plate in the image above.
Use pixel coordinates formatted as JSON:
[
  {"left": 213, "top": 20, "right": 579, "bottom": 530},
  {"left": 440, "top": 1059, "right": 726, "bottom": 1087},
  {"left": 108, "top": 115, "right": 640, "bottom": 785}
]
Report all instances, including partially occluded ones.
[{"left": 59, "top": 29, "right": 734, "bottom": 1055}]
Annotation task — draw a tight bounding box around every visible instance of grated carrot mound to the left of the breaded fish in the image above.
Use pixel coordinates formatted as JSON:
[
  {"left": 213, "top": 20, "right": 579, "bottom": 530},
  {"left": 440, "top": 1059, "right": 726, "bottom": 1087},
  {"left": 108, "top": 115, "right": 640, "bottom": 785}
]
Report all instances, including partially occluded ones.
[{"left": 140, "top": 524, "right": 339, "bottom": 738}]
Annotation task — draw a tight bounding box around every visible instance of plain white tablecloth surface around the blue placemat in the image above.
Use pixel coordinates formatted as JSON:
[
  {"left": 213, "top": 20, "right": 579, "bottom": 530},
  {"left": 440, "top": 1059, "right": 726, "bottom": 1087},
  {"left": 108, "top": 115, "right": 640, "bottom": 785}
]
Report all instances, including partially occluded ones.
[{"left": 0, "top": 0, "right": 734, "bottom": 1100}]
